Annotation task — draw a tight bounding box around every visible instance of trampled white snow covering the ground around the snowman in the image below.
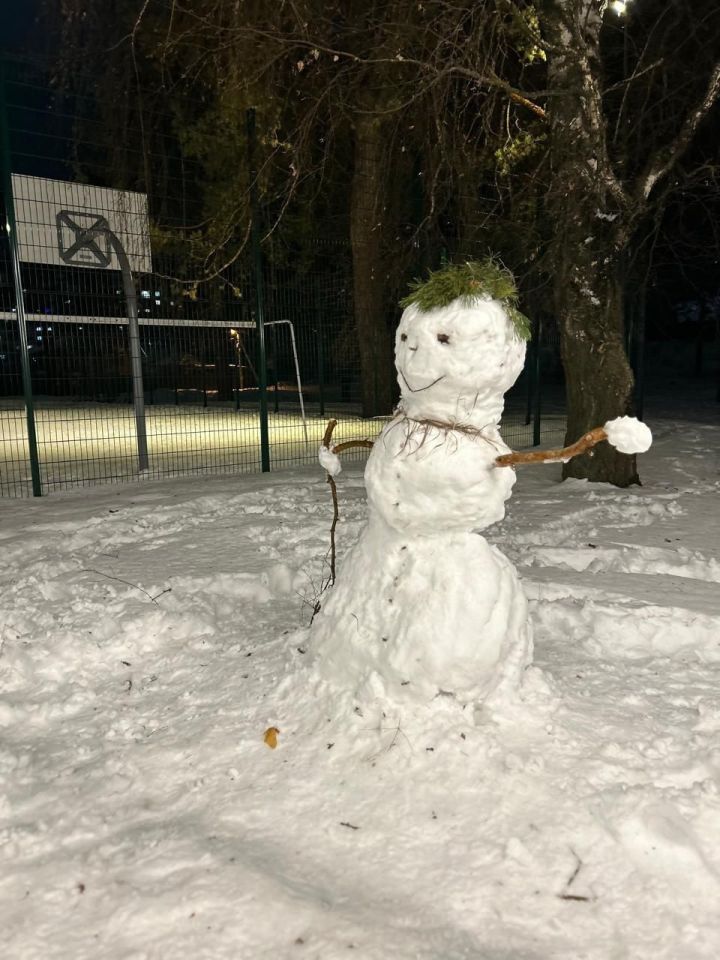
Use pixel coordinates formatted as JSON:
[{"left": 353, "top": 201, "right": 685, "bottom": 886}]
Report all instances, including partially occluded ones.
[{"left": 0, "top": 408, "right": 720, "bottom": 960}]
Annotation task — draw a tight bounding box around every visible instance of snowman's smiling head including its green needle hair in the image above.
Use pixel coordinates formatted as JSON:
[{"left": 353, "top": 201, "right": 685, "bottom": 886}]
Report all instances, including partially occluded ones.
[{"left": 395, "top": 261, "right": 528, "bottom": 429}]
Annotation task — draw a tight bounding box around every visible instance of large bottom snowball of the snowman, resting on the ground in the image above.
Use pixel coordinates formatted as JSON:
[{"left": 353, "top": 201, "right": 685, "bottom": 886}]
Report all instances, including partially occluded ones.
[{"left": 312, "top": 517, "right": 532, "bottom": 705}]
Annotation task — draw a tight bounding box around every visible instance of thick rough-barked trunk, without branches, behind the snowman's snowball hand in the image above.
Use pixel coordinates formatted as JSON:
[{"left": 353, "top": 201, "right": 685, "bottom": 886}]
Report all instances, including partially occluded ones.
[{"left": 544, "top": 0, "right": 640, "bottom": 487}]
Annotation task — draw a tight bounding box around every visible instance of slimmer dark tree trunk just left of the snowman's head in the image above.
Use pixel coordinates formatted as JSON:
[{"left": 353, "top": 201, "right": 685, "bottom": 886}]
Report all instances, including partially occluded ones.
[{"left": 350, "top": 116, "right": 394, "bottom": 417}]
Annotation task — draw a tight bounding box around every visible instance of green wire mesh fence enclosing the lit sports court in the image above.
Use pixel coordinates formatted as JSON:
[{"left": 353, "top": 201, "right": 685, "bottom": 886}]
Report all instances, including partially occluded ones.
[{"left": 0, "top": 64, "right": 562, "bottom": 496}]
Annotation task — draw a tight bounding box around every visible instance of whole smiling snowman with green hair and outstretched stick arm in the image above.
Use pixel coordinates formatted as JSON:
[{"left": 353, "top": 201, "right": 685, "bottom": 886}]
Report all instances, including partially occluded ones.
[{"left": 311, "top": 260, "right": 649, "bottom": 707}]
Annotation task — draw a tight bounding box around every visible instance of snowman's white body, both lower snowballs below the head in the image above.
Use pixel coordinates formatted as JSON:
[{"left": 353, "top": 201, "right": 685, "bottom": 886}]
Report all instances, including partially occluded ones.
[{"left": 312, "top": 414, "right": 532, "bottom": 703}]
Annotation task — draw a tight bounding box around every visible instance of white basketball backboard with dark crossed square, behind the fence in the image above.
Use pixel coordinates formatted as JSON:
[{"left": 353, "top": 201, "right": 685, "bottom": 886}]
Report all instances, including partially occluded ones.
[{"left": 12, "top": 173, "right": 152, "bottom": 273}]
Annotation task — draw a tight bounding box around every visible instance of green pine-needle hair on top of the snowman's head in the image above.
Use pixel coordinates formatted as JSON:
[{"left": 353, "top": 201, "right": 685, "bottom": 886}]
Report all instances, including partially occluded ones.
[{"left": 400, "top": 257, "right": 530, "bottom": 340}]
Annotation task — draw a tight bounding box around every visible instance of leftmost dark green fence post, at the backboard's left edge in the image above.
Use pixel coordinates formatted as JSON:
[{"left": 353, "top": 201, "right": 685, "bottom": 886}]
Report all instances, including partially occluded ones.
[{"left": 0, "top": 62, "right": 42, "bottom": 497}]
